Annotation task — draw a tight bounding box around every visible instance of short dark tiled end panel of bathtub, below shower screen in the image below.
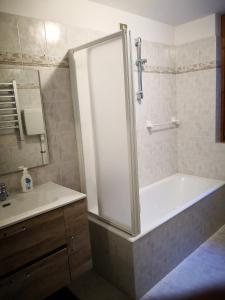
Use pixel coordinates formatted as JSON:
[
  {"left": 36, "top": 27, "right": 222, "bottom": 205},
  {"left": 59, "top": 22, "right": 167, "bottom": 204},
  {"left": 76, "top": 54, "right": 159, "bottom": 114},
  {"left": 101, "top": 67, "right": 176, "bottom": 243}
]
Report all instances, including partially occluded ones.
[{"left": 89, "top": 222, "right": 135, "bottom": 299}]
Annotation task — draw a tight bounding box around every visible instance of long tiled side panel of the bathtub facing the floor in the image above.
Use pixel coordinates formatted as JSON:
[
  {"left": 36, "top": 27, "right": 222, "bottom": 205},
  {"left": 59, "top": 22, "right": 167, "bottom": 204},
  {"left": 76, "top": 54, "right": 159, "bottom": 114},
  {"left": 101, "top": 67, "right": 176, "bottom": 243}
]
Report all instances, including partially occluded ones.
[{"left": 134, "top": 187, "right": 225, "bottom": 297}]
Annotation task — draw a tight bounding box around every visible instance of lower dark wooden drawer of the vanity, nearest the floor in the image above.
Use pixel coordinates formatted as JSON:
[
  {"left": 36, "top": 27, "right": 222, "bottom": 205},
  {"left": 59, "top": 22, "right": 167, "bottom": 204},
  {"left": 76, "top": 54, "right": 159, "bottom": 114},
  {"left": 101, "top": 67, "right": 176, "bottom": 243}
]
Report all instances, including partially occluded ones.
[{"left": 0, "top": 248, "right": 70, "bottom": 300}]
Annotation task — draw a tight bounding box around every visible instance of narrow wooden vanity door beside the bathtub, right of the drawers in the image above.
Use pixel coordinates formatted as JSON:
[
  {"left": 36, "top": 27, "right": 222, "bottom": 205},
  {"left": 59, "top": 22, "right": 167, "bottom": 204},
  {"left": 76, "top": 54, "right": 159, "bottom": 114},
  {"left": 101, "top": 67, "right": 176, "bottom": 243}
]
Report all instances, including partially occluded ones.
[{"left": 64, "top": 200, "right": 92, "bottom": 280}]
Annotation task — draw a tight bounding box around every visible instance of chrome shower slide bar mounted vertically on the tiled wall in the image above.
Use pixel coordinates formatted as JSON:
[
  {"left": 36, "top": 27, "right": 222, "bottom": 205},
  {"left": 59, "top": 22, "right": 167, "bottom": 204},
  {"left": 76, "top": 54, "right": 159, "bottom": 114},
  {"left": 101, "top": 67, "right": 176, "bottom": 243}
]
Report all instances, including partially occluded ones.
[{"left": 135, "top": 37, "right": 147, "bottom": 102}]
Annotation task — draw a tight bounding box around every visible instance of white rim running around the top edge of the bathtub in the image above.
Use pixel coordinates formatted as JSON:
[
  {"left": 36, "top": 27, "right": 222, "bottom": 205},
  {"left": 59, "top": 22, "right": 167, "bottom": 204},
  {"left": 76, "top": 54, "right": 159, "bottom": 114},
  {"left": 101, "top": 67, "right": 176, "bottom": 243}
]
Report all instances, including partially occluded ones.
[{"left": 88, "top": 173, "right": 225, "bottom": 243}]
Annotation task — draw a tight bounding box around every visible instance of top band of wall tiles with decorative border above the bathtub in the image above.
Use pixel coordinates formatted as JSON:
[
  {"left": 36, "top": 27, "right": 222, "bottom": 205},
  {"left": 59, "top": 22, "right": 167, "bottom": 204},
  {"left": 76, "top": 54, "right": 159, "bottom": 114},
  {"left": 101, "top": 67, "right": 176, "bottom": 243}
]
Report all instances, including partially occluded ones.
[{"left": 138, "top": 37, "right": 220, "bottom": 74}]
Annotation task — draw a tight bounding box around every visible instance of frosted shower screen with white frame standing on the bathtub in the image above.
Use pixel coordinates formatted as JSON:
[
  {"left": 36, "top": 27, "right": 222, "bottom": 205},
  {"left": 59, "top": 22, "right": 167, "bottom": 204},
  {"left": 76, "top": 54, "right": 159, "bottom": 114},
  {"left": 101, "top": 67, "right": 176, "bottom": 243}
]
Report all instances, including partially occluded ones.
[{"left": 70, "top": 31, "right": 140, "bottom": 235}]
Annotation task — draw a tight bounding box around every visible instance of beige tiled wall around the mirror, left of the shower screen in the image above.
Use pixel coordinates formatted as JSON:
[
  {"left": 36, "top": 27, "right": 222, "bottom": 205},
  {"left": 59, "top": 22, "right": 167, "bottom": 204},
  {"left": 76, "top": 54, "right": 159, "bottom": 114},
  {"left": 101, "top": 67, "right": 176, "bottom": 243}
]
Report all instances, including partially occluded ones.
[{"left": 0, "top": 13, "right": 102, "bottom": 191}]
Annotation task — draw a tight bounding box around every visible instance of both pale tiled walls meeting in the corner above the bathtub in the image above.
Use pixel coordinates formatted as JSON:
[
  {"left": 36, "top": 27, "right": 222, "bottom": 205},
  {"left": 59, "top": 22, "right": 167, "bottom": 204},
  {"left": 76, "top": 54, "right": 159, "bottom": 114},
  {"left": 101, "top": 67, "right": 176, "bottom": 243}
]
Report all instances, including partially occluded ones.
[{"left": 136, "top": 37, "right": 222, "bottom": 186}]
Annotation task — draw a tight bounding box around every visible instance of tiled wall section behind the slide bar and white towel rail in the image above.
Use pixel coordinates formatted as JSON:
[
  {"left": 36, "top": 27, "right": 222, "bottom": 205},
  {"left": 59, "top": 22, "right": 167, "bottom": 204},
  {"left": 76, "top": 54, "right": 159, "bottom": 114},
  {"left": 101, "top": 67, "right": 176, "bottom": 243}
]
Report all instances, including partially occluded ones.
[{"left": 134, "top": 41, "right": 178, "bottom": 186}]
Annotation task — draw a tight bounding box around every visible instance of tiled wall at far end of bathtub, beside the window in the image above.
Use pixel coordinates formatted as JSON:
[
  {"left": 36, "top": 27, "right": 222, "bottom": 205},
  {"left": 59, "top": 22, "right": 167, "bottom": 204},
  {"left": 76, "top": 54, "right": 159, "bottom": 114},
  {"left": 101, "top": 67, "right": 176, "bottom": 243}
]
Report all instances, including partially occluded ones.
[{"left": 176, "top": 38, "right": 225, "bottom": 180}]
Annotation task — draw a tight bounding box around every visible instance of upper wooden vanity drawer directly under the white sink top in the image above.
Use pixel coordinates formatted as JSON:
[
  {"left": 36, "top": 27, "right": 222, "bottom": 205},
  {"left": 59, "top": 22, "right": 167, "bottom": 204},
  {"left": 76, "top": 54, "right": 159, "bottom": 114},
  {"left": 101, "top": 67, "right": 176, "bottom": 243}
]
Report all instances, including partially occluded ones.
[{"left": 0, "top": 209, "right": 66, "bottom": 276}]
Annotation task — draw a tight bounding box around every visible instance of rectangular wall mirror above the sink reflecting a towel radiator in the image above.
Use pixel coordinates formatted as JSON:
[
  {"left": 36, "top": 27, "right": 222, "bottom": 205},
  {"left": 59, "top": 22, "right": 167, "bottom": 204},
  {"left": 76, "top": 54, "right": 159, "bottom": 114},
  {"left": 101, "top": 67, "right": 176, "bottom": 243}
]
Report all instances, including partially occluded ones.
[{"left": 0, "top": 69, "right": 49, "bottom": 175}]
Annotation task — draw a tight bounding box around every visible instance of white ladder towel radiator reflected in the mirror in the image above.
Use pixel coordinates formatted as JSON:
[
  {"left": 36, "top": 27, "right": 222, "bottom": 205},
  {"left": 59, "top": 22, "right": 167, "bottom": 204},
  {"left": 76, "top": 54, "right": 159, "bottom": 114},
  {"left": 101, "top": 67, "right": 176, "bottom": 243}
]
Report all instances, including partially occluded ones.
[{"left": 0, "top": 80, "right": 24, "bottom": 141}]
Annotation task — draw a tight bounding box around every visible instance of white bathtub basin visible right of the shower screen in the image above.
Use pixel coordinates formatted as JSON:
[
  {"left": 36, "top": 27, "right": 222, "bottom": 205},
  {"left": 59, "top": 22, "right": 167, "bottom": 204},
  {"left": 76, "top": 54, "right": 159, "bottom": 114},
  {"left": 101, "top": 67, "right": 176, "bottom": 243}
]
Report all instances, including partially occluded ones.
[{"left": 140, "top": 173, "right": 225, "bottom": 235}]
